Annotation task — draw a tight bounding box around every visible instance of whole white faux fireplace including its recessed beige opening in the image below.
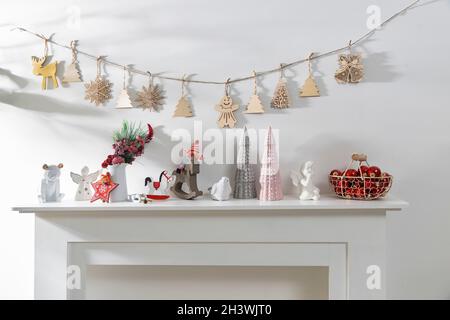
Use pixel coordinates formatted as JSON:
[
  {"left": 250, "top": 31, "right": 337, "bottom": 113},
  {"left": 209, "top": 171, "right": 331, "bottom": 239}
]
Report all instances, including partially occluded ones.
[{"left": 14, "top": 196, "right": 407, "bottom": 299}]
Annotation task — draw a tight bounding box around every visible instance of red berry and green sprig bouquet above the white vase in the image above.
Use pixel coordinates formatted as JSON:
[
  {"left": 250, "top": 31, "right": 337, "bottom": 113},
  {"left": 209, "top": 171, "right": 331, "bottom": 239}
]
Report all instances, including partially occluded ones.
[{"left": 102, "top": 121, "right": 153, "bottom": 168}]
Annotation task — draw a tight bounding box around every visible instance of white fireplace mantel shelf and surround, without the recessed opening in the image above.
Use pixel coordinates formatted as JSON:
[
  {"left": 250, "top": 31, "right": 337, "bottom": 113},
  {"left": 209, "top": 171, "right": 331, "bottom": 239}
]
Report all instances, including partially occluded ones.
[{"left": 13, "top": 196, "right": 408, "bottom": 299}]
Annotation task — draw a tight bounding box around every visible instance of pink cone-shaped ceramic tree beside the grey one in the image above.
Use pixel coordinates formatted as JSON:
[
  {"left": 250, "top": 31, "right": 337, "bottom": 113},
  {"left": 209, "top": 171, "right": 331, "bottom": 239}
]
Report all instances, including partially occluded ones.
[{"left": 259, "top": 127, "right": 283, "bottom": 201}]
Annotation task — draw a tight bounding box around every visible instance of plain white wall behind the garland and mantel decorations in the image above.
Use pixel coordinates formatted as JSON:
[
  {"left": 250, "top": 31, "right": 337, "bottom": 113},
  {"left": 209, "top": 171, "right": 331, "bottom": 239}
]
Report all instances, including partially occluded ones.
[{"left": 0, "top": 0, "right": 450, "bottom": 298}]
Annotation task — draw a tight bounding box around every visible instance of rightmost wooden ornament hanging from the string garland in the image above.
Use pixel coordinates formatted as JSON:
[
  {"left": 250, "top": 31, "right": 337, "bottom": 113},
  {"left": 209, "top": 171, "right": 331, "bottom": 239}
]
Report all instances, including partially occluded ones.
[{"left": 334, "top": 40, "right": 364, "bottom": 83}]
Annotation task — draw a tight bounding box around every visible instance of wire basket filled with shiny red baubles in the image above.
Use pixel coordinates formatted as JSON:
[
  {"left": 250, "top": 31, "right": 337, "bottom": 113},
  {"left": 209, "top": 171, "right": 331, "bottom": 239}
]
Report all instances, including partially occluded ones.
[{"left": 329, "top": 154, "right": 393, "bottom": 200}]
